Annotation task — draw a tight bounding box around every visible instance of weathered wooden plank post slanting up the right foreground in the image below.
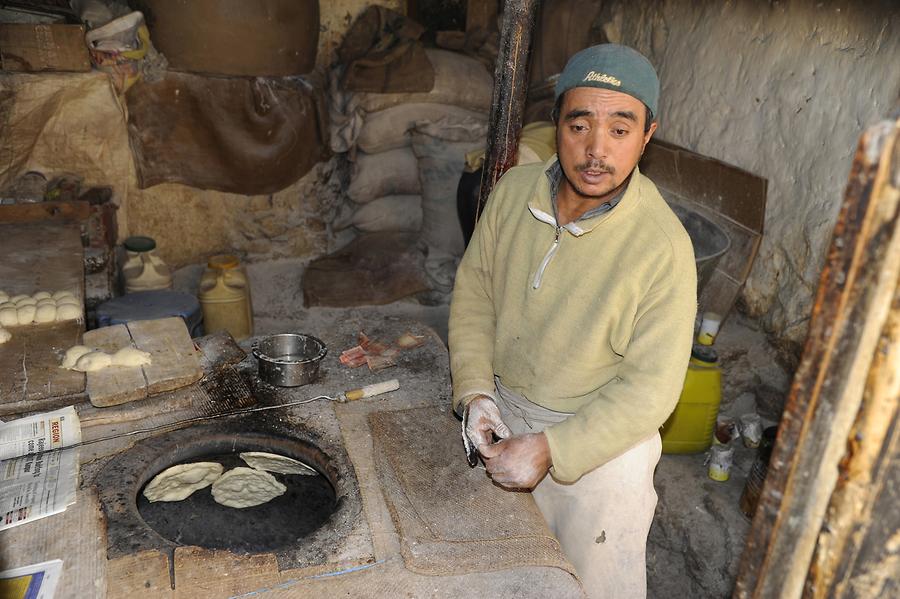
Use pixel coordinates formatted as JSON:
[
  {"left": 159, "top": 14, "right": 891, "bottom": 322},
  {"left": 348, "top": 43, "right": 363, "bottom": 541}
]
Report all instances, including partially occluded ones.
[{"left": 734, "top": 115, "right": 900, "bottom": 599}]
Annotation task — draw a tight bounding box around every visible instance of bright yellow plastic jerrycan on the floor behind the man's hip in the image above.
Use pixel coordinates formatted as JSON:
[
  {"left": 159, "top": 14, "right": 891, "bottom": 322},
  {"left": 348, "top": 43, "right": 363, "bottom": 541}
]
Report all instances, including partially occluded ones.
[{"left": 660, "top": 344, "right": 722, "bottom": 453}]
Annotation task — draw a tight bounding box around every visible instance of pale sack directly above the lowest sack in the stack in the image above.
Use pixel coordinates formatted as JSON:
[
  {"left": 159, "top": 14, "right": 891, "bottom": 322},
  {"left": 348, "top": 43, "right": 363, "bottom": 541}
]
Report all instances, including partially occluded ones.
[{"left": 347, "top": 148, "right": 422, "bottom": 204}]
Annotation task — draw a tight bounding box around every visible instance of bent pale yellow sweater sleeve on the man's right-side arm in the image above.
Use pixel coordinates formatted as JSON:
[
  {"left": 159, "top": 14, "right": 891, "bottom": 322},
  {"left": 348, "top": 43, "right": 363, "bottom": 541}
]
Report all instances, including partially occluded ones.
[{"left": 544, "top": 252, "right": 697, "bottom": 482}]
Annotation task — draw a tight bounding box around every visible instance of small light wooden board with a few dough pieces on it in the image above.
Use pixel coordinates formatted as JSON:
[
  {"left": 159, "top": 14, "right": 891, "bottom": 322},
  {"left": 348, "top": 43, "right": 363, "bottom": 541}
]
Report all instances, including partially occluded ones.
[{"left": 84, "top": 316, "right": 203, "bottom": 408}]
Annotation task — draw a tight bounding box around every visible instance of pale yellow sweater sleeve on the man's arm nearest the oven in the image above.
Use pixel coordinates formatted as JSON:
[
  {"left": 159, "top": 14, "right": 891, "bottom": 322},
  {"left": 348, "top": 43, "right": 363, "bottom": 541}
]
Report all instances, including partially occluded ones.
[{"left": 448, "top": 181, "right": 502, "bottom": 412}]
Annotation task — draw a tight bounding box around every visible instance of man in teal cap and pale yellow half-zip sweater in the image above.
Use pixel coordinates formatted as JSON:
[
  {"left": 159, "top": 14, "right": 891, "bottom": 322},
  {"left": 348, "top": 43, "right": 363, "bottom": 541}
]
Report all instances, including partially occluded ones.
[{"left": 449, "top": 44, "right": 697, "bottom": 599}]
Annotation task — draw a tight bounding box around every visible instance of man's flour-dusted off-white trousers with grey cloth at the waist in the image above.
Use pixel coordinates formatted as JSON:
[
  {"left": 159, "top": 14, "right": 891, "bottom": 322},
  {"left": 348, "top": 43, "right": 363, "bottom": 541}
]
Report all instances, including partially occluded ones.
[{"left": 496, "top": 380, "right": 662, "bottom": 599}]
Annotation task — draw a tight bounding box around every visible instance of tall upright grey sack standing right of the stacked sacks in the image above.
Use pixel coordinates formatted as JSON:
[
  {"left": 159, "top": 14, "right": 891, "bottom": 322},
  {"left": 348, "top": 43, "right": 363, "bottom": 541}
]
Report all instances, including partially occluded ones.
[{"left": 412, "top": 118, "right": 487, "bottom": 291}]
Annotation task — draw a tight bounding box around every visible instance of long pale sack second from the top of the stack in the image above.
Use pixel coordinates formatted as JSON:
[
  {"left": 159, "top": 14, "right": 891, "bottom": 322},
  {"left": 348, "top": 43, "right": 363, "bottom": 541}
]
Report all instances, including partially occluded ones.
[{"left": 356, "top": 102, "right": 487, "bottom": 154}]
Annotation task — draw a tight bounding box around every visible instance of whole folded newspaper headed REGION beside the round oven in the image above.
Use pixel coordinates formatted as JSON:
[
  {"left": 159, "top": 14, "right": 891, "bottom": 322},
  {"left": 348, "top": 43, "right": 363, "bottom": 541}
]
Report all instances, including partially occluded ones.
[{"left": 0, "top": 406, "right": 81, "bottom": 530}]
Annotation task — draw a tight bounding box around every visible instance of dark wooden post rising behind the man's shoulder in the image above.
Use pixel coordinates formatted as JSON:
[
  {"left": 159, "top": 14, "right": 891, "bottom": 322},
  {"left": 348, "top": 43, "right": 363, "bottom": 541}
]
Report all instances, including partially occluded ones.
[{"left": 476, "top": 0, "right": 540, "bottom": 218}]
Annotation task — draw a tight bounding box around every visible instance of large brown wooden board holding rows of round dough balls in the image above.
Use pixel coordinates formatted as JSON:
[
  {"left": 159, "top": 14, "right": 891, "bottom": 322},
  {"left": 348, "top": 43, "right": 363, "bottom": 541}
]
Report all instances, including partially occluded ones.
[{"left": 0, "top": 223, "right": 85, "bottom": 415}]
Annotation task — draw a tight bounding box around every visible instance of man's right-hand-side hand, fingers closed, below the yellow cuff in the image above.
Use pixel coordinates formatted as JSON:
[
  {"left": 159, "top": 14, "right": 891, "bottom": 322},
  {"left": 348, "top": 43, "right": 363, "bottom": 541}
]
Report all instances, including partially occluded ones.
[{"left": 478, "top": 433, "right": 553, "bottom": 489}]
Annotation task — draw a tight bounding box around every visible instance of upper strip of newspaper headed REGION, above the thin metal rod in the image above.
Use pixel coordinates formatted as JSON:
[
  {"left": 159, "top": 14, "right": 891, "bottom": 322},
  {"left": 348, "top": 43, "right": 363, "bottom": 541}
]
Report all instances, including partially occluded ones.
[{"left": 0, "top": 406, "right": 81, "bottom": 460}]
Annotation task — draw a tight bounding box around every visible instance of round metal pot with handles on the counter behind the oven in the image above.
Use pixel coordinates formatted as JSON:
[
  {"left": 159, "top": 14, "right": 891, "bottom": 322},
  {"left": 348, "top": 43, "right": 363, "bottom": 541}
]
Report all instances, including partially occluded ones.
[{"left": 252, "top": 333, "right": 328, "bottom": 387}]
